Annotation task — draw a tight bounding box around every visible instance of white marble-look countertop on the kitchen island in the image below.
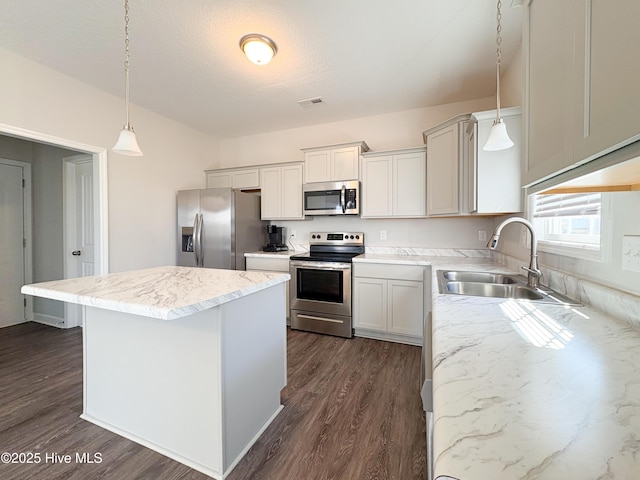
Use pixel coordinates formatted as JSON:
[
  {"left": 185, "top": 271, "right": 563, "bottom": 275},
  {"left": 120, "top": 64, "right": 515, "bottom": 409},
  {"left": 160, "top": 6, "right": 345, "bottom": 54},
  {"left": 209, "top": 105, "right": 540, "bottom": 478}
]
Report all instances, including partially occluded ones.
[{"left": 21, "top": 266, "right": 290, "bottom": 320}]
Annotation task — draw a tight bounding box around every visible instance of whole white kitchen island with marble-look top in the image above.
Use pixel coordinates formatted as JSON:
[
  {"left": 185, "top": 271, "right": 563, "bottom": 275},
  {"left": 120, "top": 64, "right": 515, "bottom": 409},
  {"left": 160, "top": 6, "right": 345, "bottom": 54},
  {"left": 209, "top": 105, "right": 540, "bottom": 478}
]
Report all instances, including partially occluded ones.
[{"left": 22, "top": 266, "right": 289, "bottom": 479}]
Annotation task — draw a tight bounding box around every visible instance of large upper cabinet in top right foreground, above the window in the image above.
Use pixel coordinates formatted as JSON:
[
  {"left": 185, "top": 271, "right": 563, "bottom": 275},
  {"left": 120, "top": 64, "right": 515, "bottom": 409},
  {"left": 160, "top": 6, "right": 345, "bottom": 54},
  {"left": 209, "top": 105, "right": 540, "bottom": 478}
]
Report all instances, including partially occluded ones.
[{"left": 522, "top": 0, "right": 640, "bottom": 186}]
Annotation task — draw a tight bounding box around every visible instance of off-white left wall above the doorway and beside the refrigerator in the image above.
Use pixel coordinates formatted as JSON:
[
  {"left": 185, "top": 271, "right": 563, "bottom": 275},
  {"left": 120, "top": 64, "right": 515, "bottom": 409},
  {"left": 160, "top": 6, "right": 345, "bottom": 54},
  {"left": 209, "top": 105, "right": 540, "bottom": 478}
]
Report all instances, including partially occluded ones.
[{"left": 0, "top": 49, "right": 219, "bottom": 272}]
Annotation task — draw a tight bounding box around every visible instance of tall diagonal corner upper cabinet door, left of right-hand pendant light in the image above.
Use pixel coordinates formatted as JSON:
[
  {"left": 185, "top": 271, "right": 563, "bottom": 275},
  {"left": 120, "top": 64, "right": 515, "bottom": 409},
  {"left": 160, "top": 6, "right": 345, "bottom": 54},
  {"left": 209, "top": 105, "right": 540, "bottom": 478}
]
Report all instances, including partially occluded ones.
[{"left": 427, "top": 123, "right": 460, "bottom": 215}]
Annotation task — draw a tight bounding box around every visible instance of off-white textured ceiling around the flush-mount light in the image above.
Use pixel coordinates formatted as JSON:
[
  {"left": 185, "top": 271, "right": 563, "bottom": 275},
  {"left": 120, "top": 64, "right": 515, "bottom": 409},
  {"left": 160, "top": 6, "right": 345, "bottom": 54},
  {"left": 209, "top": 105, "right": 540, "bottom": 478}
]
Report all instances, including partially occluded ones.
[{"left": 0, "top": 0, "right": 522, "bottom": 137}]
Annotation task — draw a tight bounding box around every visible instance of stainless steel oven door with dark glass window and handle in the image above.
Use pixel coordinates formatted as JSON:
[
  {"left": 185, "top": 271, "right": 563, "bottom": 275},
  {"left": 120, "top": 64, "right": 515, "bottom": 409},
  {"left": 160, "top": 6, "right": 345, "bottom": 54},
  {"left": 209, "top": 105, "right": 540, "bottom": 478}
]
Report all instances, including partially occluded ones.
[{"left": 289, "top": 260, "right": 351, "bottom": 317}]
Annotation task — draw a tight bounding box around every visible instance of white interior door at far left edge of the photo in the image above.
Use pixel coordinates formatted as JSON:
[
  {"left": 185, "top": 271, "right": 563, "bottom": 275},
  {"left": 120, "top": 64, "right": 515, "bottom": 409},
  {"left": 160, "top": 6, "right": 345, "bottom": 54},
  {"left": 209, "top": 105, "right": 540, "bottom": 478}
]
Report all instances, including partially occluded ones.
[{"left": 0, "top": 160, "right": 25, "bottom": 327}]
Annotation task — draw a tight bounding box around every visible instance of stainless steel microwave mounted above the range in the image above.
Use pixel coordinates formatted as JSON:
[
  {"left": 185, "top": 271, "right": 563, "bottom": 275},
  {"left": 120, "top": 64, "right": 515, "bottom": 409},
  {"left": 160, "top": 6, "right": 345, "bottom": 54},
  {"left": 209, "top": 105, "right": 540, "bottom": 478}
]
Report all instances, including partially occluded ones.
[{"left": 302, "top": 180, "right": 360, "bottom": 215}]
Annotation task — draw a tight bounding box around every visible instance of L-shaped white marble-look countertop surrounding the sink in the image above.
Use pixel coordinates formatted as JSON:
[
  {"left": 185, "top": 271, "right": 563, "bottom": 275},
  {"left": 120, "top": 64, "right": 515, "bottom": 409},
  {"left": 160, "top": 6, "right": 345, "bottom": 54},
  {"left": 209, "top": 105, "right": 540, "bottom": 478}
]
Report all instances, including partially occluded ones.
[{"left": 353, "top": 253, "right": 640, "bottom": 480}]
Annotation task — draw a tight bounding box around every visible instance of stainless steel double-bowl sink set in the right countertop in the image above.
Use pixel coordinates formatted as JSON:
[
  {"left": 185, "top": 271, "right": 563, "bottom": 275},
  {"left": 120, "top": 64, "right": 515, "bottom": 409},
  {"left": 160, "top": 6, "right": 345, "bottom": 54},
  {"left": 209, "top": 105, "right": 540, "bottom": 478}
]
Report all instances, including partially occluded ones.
[{"left": 436, "top": 270, "right": 581, "bottom": 306}]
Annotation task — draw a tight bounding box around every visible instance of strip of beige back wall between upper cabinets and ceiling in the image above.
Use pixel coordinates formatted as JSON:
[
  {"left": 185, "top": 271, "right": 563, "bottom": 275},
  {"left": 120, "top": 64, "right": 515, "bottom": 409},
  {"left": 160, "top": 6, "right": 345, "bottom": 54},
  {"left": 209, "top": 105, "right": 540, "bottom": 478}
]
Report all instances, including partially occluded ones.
[{"left": 218, "top": 97, "right": 495, "bottom": 168}]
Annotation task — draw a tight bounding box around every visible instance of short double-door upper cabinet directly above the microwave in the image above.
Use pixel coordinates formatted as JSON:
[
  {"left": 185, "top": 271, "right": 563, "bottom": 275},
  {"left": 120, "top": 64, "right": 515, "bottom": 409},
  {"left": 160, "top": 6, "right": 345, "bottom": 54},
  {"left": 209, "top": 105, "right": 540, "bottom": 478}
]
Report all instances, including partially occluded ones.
[{"left": 302, "top": 142, "right": 369, "bottom": 183}]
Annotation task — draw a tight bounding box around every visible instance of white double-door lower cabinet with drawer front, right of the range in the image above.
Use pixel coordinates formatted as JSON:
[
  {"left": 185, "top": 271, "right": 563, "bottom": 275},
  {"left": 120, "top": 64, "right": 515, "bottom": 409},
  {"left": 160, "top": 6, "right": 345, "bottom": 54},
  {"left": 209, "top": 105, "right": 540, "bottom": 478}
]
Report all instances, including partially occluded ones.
[{"left": 353, "top": 262, "right": 430, "bottom": 345}]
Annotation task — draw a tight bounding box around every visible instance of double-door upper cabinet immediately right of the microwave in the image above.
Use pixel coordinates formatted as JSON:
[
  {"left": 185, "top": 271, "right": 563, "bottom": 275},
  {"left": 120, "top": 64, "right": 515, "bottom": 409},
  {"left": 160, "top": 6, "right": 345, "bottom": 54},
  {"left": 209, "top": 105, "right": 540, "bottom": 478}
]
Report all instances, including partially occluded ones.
[{"left": 361, "top": 147, "right": 426, "bottom": 218}]
